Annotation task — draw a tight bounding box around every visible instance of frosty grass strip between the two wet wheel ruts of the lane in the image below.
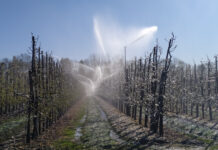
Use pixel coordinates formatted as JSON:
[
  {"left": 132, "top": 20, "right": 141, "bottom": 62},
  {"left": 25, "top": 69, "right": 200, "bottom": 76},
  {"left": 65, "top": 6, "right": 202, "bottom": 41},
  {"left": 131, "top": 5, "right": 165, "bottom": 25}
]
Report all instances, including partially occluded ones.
[{"left": 81, "top": 97, "right": 123, "bottom": 150}]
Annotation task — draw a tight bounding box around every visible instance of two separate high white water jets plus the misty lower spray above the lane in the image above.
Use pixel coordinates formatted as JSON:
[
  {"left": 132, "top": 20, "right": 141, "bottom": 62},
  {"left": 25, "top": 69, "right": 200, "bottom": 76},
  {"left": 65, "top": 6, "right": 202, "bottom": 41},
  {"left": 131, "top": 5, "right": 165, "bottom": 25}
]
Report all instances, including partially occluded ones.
[{"left": 74, "top": 17, "right": 157, "bottom": 95}]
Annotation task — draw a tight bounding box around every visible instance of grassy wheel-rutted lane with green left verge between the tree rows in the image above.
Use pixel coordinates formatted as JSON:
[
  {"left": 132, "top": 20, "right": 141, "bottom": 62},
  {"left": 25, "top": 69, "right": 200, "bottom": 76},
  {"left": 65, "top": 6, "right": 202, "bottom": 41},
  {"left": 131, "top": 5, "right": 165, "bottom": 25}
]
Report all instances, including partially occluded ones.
[{"left": 54, "top": 97, "right": 127, "bottom": 150}]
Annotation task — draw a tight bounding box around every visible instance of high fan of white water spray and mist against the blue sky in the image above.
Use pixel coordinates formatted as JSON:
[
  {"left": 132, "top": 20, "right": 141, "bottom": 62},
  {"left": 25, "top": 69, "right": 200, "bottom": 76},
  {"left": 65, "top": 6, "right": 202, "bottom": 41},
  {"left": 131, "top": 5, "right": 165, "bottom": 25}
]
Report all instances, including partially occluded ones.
[{"left": 93, "top": 16, "right": 158, "bottom": 58}]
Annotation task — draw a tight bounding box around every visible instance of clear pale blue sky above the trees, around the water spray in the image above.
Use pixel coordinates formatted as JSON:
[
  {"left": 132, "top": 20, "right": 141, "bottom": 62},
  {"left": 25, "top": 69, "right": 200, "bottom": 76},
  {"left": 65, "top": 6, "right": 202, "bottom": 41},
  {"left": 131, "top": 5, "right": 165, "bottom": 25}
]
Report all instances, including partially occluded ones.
[{"left": 0, "top": 0, "right": 218, "bottom": 63}]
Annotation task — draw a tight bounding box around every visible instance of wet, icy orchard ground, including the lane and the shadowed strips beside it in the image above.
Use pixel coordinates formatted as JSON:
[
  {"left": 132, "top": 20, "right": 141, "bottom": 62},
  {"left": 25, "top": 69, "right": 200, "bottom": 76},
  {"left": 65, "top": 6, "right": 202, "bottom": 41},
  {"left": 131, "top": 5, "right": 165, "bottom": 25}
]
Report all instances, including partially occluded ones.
[{"left": 2, "top": 96, "right": 218, "bottom": 150}]
